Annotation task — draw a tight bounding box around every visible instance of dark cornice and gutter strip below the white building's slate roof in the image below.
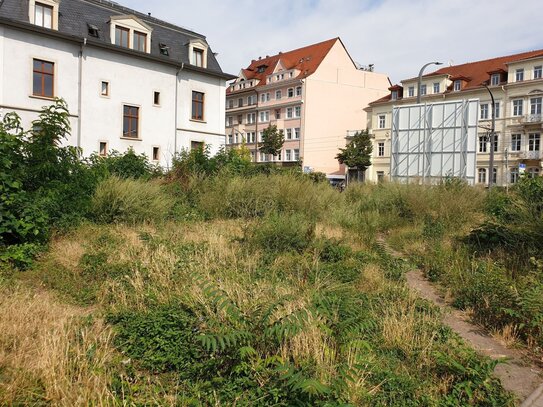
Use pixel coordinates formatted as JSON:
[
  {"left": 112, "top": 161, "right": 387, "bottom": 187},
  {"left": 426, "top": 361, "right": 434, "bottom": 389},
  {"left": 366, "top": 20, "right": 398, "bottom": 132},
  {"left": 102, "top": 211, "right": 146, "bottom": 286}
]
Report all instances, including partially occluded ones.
[{"left": 0, "top": 17, "right": 237, "bottom": 81}]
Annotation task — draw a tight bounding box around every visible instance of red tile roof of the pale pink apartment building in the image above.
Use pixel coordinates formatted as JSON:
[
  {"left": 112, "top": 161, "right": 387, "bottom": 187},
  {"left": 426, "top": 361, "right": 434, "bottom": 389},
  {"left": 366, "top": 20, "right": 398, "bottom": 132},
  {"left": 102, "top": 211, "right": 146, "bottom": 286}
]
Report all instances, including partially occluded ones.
[{"left": 227, "top": 38, "right": 340, "bottom": 94}]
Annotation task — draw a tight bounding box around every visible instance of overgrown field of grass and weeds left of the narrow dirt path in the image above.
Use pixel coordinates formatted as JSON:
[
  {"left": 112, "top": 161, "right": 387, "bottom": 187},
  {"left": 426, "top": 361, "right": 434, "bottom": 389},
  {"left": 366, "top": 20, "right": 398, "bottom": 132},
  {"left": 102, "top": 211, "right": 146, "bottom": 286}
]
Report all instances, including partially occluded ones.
[{"left": 0, "top": 169, "right": 528, "bottom": 406}]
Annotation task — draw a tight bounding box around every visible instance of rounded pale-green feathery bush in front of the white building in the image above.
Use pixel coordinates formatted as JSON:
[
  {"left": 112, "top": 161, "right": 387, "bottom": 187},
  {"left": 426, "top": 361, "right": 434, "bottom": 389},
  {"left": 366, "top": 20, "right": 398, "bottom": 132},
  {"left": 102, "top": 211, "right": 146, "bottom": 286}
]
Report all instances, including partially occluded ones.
[{"left": 92, "top": 177, "right": 174, "bottom": 223}]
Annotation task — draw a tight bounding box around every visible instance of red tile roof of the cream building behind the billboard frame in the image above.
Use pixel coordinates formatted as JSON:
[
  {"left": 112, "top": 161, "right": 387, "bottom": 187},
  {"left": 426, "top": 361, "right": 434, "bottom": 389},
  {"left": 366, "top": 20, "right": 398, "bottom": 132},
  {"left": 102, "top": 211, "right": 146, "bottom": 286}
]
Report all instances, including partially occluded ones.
[{"left": 370, "top": 50, "right": 543, "bottom": 105}]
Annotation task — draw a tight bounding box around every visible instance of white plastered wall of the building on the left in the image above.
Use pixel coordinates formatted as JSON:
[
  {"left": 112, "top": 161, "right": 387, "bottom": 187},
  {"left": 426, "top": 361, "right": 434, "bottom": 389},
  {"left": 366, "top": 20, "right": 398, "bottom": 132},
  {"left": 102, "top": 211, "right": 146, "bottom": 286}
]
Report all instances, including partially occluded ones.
[{"left": 0, "top": 27, "right": 226, "bottom": 167}]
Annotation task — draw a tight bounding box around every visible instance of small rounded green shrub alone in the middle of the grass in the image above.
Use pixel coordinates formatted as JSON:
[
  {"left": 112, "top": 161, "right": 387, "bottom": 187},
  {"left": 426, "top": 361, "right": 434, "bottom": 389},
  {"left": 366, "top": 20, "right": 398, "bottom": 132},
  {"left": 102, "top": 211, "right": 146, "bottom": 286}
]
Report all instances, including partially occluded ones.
[{"left": 248, "top": 213, "right": 315, "bottom": 252}]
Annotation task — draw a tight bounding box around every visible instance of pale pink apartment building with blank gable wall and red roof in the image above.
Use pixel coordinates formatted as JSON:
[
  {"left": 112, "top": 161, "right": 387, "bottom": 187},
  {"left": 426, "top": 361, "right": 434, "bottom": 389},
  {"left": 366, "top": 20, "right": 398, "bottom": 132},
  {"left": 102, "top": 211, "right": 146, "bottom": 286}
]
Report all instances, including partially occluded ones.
[{"left": 226, "top": 38, "right": 390, "bottom": 179}]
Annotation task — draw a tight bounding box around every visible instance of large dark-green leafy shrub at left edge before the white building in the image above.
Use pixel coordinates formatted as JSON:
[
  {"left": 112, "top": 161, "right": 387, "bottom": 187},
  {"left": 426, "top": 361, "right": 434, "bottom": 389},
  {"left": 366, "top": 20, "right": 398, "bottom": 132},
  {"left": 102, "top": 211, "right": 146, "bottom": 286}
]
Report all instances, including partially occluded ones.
[{"left": 0, "top": 99, "right": 97, "bottom": 253}]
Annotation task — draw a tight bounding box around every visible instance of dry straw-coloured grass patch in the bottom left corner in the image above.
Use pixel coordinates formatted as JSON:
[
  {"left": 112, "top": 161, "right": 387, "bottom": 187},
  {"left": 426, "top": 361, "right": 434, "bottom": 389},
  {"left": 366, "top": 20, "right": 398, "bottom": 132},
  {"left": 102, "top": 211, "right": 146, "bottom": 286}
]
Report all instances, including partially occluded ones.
[{"left": 0, "top": 287, "right": 113, "bottom": 406}]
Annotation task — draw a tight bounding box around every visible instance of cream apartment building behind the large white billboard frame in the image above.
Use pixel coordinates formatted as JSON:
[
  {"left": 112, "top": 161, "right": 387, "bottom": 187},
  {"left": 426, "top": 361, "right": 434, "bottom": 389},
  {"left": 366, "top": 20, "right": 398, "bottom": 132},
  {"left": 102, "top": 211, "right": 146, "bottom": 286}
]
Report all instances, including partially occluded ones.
[{"left": 366, "top": 50, "right": 543, "bottom": 186}]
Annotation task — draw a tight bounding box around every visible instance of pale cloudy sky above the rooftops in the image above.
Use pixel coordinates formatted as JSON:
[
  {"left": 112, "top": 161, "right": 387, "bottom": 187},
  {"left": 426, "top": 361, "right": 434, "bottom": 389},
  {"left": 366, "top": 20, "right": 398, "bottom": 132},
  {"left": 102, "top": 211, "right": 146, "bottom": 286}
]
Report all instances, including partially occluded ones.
[{"left": 122, "top": 0, "right": 543, "bottom": 83}]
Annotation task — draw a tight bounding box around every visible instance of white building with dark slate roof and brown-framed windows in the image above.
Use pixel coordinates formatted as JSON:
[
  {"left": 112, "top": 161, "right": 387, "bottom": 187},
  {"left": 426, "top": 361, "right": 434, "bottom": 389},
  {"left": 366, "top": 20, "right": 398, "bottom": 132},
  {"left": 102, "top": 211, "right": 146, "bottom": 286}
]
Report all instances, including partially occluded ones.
[{"left": 0, "top": 0, "right": 233, "bottom": 166}]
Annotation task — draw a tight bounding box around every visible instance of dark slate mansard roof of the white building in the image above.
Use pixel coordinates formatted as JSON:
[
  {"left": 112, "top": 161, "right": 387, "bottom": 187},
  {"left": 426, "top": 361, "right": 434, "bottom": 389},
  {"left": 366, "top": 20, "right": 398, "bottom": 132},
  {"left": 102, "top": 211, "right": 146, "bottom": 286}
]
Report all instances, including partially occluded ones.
[{"left": 0, "top": 0, "right": 222, "bottom": 73}]
